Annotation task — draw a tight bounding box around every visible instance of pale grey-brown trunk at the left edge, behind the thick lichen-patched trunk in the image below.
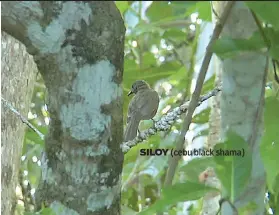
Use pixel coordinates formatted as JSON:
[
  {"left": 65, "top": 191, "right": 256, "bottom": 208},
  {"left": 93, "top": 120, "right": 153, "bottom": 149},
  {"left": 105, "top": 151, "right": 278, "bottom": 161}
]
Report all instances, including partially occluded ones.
[{"left": 1, "top": 32, "right": 37, "bottom": 215}]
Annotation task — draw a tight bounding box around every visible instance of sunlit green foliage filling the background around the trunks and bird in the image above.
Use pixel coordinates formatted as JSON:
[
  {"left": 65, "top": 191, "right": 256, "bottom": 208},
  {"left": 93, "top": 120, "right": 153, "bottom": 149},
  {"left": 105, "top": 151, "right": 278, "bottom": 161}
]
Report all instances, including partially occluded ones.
[{"left": 15, "top": 1, "right": 279, "bottom": 214}]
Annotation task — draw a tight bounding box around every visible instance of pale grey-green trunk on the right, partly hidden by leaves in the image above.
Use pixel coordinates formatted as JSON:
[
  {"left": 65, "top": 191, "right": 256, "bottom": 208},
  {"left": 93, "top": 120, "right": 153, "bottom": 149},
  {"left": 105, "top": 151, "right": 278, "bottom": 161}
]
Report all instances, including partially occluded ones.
[{"left": 204, "top": 2, "right": 267, "bottom": 215}]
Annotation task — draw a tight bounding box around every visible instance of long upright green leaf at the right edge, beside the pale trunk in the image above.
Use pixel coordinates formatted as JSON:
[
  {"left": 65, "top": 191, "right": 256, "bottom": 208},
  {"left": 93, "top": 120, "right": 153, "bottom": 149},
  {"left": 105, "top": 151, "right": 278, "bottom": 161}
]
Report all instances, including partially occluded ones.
[{"left": 260, "top": 97, "right": 279, "bottom": 193}]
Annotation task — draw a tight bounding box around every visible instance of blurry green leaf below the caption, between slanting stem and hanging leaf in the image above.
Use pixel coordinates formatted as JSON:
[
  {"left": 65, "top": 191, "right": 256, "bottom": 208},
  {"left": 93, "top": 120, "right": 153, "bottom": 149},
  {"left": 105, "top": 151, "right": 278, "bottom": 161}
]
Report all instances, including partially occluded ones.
[{"left": 180, "top": 157, "right": 215, "bottom": 181}]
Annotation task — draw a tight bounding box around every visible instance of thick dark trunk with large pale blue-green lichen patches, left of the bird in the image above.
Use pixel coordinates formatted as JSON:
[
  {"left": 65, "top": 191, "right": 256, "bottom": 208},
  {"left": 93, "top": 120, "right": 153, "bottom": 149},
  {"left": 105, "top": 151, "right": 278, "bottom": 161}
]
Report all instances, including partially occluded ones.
[{"left": 2, "top": 1, "right": 125, "bottom": 215}]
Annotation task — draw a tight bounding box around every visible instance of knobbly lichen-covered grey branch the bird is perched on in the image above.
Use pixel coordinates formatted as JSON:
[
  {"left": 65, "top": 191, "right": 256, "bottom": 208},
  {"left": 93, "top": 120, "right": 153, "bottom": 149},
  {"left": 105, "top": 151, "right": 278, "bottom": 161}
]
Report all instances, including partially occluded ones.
[{"left": 121, "top": 87, "right": 221, "bottom": 153}]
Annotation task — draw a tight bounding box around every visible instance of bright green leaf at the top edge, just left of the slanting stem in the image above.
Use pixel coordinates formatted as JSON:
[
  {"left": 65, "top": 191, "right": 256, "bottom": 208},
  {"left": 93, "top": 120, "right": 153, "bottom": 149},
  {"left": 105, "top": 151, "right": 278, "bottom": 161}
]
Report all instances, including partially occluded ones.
[{"left": 186, "top": 1, "right": 211, "bottom": 22}]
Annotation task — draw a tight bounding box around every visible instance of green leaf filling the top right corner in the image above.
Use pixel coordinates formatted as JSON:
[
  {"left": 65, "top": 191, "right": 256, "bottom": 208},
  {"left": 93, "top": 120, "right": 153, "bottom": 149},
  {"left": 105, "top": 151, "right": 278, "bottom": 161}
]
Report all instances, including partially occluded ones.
[{"left": 246, "top": 1, "right": 279, "bottom": 30}]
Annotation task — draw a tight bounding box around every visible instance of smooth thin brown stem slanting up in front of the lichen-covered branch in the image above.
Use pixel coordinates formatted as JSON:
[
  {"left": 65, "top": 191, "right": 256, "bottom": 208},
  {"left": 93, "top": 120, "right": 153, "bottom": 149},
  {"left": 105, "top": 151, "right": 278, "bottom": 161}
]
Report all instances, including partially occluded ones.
[{"left": 164, "top": 1, "right": 235, "bottom": 186}]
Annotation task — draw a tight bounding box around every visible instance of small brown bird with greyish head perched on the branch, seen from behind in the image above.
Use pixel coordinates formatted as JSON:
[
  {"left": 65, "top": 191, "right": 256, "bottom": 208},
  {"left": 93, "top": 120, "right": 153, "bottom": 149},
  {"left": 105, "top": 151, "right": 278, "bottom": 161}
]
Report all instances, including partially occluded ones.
[{"left": 124, "top": 80, "right": 159, "bottom": 142}]
